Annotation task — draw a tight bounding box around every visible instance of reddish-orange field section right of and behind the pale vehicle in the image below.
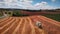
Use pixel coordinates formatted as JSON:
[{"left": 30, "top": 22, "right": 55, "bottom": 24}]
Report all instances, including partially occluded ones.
[{"left": 31, "top": 16, "right": 60, "bottom": 34}]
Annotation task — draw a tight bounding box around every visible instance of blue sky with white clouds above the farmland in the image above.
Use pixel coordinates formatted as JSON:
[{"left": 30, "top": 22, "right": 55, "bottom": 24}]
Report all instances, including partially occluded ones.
[{"left": 0, "top": 0, "right": 60, "bottom": 10}]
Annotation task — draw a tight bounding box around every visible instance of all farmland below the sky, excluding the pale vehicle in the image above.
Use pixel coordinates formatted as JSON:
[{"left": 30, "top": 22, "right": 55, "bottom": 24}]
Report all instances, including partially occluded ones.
[{"left": 0, "top": 9, "right": 60, "bottom": 34}]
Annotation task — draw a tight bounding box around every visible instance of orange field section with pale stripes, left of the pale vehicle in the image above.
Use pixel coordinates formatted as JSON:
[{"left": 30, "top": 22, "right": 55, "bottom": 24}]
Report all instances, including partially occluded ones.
[{"left": 0, "top": 17, "right": 45, "bottom": 34}]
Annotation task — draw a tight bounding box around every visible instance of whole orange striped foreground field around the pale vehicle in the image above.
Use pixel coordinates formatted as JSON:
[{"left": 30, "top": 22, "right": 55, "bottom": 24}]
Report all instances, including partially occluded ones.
[{"left": 0, "top": 16, "right": 60, "bottom": 34}]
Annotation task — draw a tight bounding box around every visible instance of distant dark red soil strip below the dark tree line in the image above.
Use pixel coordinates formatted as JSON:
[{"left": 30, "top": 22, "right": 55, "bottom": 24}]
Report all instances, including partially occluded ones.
[{"left": 21, "top": 11, "right": 60, "bottom": 15}]
